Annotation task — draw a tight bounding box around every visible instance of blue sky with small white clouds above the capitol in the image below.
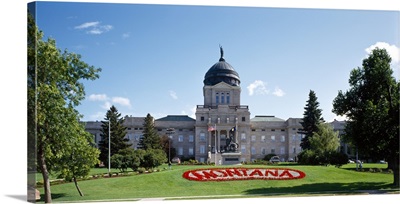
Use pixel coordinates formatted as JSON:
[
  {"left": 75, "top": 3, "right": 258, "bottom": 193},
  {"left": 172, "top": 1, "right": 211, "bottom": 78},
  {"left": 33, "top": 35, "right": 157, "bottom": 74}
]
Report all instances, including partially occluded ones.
[{"left": 32, "top": 2, "right": 400, "bottom": 121}]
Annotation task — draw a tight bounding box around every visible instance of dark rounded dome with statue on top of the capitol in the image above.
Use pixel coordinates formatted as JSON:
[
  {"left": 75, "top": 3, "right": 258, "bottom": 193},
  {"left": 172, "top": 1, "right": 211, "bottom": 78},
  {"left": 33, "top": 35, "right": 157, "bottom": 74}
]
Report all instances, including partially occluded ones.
[{"left": 203, "top": 47, "right": 240, "bottom": 86}]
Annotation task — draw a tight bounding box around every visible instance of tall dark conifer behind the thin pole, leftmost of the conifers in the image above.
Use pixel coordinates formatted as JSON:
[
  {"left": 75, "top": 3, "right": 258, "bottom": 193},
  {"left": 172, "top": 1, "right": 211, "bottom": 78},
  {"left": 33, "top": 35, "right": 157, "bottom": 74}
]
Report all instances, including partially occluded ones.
[{"left": 99, "top": 105, "right": 132, "bottom": 164}]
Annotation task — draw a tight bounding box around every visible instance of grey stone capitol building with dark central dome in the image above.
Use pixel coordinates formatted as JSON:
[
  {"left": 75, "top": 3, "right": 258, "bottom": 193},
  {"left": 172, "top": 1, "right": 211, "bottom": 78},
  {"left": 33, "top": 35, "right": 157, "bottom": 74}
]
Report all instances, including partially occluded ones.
[{"left": 86, "top": 48, "right": 344, "bottom": 164}]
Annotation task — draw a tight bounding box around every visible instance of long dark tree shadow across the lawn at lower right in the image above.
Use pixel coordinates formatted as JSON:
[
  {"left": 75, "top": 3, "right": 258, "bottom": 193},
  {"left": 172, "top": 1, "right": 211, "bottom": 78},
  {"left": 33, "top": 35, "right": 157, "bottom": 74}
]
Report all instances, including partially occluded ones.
[{"left": 243, "top": 182, "right": 399, "bottom": 195}]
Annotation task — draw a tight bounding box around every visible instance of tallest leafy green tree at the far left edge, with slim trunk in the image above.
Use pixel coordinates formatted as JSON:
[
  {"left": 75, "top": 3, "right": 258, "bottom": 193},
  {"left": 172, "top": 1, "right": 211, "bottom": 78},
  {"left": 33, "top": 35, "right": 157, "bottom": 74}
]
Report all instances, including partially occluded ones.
[{"left": 27, "top": 11, "right": 101, "bottom": 203}]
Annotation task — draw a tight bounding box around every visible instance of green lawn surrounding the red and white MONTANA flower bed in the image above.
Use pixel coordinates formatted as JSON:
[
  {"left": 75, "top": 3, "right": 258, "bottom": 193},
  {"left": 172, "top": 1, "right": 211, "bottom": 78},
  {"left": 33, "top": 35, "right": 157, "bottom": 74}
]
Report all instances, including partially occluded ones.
[{"left": 38, "top": 164, "right": 398, "bottom": 202}]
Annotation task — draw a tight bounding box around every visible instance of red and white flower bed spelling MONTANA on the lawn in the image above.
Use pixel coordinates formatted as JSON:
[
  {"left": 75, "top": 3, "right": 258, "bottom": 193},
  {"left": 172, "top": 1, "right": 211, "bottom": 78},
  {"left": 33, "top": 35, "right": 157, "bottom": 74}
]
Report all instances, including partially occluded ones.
[{"left": 182, "top": 168, "right": 306, "bottom": 181}]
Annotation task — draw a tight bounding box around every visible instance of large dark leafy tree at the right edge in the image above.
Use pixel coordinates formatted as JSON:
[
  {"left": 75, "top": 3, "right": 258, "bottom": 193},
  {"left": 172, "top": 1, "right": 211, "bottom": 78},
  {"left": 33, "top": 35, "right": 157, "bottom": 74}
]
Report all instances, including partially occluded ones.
[{"left": 332, "top": 48, "right": 400, "bottom": 186}]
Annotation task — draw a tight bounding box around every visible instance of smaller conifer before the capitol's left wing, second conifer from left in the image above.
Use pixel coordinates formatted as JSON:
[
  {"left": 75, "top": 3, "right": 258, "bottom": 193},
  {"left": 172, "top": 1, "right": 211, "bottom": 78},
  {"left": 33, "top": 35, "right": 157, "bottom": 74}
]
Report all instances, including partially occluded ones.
[{"left": 138, "top": 113, "right": 161, "bottom": 150}]
